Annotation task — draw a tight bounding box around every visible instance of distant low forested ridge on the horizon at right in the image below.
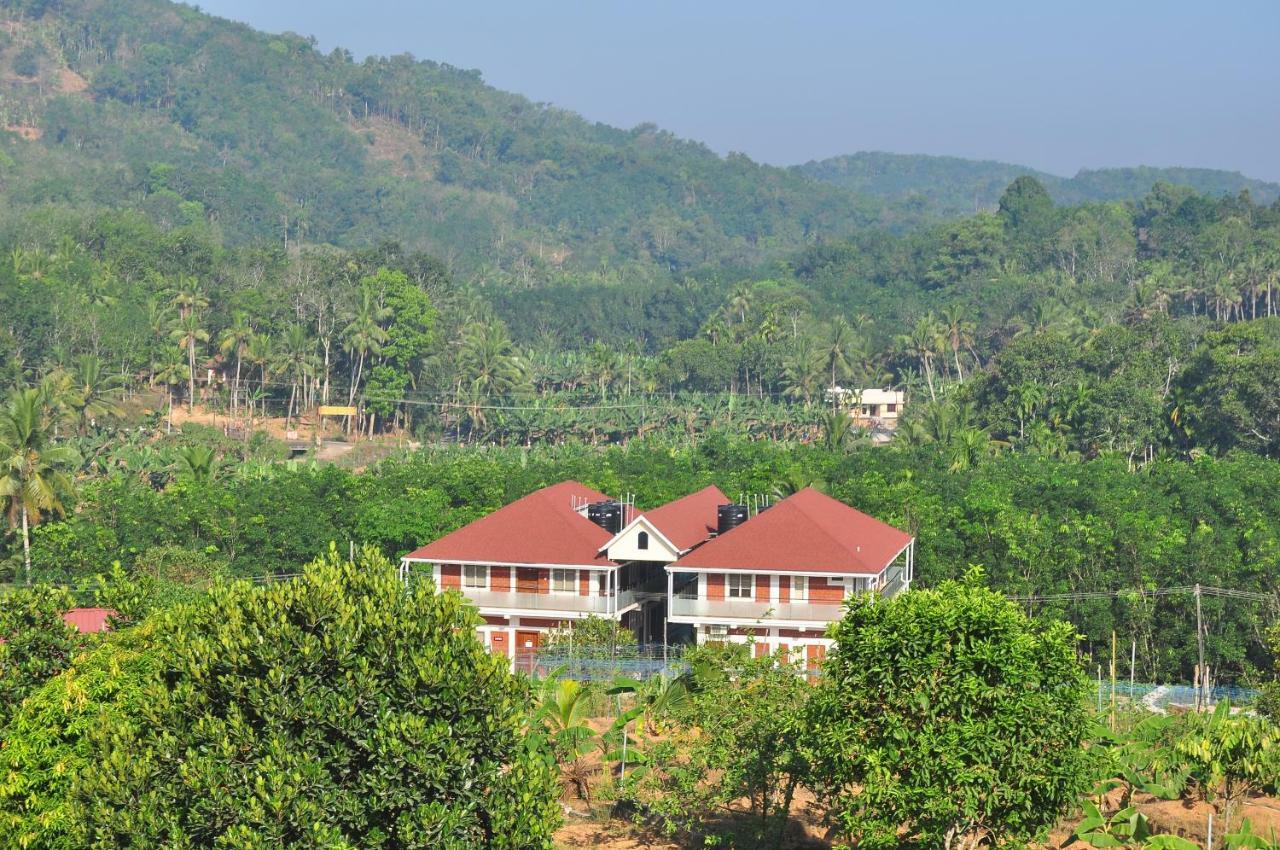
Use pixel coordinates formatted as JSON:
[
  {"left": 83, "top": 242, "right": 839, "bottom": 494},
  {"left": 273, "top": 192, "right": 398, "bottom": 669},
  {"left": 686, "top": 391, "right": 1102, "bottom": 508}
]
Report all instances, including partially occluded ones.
[{"left": 796, "top": 151, "right": 1280, "bottom": 216}]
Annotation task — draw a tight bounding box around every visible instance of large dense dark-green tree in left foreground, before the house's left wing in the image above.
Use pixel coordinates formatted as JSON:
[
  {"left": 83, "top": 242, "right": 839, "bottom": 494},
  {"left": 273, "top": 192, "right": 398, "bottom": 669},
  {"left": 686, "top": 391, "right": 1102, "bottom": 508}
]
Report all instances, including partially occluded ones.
[{"left": 77, "top": 549, "right": 559, "bottom": 850}]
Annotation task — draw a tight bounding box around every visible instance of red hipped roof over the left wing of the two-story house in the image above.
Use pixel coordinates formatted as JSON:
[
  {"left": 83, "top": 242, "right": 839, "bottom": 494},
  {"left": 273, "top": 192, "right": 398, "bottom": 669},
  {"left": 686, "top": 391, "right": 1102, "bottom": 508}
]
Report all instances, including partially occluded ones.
[{"left": 406, "top": 481, "right": 613, "bottom": 566}]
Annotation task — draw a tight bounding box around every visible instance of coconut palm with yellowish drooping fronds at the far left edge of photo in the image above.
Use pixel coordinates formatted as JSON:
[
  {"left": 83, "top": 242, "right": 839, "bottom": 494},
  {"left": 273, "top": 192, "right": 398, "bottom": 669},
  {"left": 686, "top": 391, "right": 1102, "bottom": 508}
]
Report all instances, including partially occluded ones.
[{"left": 0, "top": 389, "right": 79, "bottom": 584}]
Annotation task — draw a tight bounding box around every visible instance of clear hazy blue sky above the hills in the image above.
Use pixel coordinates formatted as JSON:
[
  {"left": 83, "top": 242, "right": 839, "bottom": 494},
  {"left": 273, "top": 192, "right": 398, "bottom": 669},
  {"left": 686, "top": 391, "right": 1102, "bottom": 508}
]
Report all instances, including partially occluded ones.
[{"left": 192, "top": 0, "right": 1280, "bottom": 179}]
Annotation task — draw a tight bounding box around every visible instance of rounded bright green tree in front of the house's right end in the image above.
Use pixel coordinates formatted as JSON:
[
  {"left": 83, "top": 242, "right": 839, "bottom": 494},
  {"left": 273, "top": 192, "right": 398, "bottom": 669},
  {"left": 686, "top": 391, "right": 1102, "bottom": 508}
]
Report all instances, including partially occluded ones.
[{"left": 808, "top": 571, "right": 1092, "bottom": 850}]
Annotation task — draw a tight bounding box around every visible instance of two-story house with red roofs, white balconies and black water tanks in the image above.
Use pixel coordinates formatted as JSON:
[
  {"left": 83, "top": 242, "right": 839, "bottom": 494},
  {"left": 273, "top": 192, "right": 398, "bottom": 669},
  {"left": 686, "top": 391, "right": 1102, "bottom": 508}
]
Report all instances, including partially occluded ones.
[{"left": 402, "top": 481, "right": 911, "bottom": 659}]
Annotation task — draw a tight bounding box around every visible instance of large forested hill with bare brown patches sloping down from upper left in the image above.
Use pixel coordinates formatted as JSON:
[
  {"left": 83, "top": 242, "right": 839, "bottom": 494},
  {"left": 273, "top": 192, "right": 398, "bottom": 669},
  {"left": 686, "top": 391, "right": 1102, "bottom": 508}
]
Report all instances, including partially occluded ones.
[{"left": 0, "top": 0, "right": 901, "bottom": 285}]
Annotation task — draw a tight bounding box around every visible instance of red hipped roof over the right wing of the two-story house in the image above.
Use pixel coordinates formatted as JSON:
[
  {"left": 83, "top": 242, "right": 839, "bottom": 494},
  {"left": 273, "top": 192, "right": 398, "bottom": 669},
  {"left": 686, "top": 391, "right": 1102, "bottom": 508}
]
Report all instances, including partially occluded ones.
[{"left": 671, "top": 488, "right": 911, "bottom": 575}]
